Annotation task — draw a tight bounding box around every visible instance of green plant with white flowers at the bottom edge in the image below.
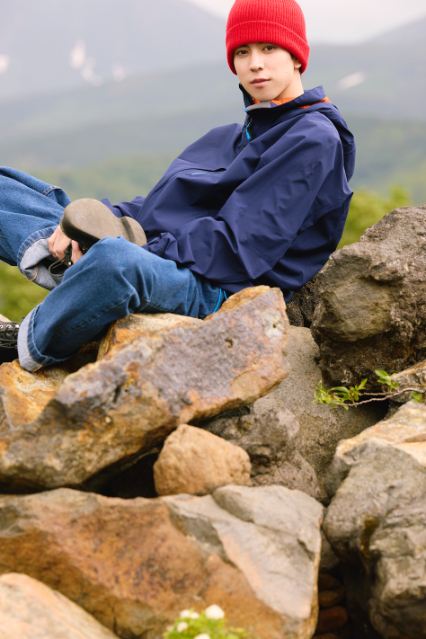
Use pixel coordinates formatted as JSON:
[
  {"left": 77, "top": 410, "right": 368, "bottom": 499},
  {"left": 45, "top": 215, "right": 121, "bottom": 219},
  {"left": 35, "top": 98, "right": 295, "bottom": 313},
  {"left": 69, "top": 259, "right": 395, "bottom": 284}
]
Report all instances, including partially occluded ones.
[{"left": 163, "top": 604, "right": 249, "bottom": 639}]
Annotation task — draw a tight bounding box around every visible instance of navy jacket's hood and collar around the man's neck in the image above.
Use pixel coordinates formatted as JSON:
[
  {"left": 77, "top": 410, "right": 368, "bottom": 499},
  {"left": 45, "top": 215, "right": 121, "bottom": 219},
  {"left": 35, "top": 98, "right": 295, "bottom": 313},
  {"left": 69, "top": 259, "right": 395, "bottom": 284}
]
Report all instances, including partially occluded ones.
[{"left": 240, "top": 84, "right": 356, "bottom": 181}]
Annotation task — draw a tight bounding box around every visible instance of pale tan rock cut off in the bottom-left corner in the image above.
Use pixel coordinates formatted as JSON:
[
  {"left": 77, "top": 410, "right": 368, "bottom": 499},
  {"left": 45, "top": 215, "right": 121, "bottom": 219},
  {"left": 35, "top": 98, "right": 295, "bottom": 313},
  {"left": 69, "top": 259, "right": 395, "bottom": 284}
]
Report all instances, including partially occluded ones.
[{"left": 0, "top": 573, "right": 117, "bottom": 639}]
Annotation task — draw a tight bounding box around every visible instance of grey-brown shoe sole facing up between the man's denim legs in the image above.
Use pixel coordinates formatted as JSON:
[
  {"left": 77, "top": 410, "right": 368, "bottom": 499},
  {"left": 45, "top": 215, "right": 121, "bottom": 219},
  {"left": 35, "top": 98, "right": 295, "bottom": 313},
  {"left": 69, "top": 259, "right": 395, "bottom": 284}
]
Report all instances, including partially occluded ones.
[{"left": 60, "top": 198, "right": 147, "bottom": 251}]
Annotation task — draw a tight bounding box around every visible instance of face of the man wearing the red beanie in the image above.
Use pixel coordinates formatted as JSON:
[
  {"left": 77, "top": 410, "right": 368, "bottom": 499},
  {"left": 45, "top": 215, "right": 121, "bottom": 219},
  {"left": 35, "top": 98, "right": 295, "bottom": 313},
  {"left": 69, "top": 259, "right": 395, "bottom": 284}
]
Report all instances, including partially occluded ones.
[{"left": 234, "top": 42, "right": 303, "bottom": 102}]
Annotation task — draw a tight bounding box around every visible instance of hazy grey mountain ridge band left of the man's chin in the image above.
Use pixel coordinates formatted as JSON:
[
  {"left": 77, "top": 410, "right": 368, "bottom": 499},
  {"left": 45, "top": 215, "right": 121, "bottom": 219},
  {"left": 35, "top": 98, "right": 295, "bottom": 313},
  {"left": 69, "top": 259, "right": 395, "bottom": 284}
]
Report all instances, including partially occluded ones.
[{"left": 0, "top": 60, "right": 240, "bottom": 142}]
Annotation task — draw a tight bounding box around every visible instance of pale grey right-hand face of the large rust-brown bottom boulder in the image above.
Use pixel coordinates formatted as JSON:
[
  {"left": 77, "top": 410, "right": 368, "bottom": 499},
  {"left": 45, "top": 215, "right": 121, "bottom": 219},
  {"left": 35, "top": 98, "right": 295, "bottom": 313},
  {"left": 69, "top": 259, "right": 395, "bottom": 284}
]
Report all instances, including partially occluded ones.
[{"left": 165, "top": 486, "right": 322, "bottom": 637}]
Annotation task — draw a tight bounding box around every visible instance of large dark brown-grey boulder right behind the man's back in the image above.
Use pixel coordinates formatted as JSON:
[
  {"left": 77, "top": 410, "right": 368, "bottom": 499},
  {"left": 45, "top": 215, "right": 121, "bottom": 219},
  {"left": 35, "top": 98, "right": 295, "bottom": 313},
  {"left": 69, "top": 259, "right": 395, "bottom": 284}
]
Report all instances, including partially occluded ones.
[{"left": 311, "top": 205, "right": 426, "bottom": 388}]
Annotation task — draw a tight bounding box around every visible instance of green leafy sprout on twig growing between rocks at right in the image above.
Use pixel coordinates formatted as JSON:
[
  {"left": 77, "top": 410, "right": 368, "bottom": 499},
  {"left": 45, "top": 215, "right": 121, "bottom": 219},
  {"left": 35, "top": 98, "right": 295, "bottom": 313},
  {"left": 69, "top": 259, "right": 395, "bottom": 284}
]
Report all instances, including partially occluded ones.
[{"left": 313, "top": 369, "right": 426, "bottom": 410}]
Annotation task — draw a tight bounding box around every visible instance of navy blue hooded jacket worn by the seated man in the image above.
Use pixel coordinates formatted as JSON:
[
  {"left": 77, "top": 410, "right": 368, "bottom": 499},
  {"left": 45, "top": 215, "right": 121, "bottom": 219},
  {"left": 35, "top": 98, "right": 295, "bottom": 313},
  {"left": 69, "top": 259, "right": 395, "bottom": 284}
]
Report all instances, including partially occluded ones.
[{"left": 104, "top": 87, "right": 355, "bottom": 301}]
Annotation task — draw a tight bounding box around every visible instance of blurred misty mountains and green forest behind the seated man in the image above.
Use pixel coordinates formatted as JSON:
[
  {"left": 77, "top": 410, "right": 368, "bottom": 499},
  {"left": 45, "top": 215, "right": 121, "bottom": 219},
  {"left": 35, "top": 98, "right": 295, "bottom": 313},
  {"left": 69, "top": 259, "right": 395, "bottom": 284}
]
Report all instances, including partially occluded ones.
[{"left": 0, "top": 0, "right": 426, "bottom": 321}]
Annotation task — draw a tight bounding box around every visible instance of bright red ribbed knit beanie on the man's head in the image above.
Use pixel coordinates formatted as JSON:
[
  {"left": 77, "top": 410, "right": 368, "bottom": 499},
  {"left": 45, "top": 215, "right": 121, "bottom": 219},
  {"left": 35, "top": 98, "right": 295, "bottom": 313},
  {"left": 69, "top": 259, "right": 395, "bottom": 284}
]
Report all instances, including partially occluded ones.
[{"left": 226, "top": 0, "right": 310, "bottom": 73}]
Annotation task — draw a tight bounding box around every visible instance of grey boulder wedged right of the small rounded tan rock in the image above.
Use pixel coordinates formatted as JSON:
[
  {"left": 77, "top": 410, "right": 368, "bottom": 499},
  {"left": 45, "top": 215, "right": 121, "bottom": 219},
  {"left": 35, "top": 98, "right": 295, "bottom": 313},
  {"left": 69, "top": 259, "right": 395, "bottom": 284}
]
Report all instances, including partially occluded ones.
[{"left": 203, "top": 326, "right": 387, "bottom": 501}]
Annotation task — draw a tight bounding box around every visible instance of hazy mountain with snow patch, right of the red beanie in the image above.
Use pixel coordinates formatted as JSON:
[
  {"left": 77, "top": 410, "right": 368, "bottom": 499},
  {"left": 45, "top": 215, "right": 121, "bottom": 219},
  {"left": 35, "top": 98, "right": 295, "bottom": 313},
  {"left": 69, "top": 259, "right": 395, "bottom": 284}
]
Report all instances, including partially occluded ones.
[{"left": 303, "top": 20, "right": 426, "bottom": 120}]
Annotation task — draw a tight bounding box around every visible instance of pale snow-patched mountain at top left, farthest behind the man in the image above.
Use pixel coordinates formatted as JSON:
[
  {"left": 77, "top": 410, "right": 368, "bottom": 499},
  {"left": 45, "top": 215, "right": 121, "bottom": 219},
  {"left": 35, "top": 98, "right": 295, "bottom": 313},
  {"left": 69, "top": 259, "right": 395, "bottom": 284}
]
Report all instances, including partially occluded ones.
[{"left": 0, "top": 0, "right": 225, "bottom": 101}]
